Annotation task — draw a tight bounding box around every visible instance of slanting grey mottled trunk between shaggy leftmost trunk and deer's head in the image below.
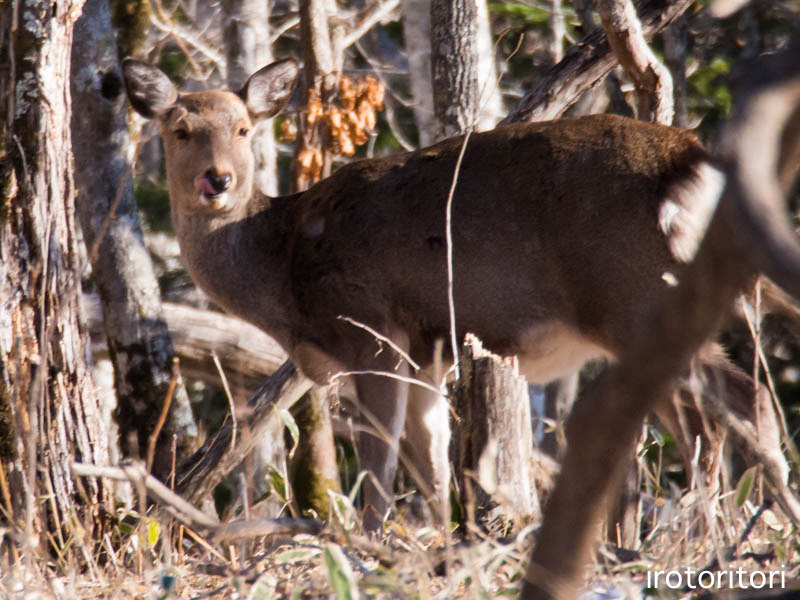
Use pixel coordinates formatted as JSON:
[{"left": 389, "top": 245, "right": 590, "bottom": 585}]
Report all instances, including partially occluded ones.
[{"left": 72, "top": 0, "right": 197, "bottom": 479}]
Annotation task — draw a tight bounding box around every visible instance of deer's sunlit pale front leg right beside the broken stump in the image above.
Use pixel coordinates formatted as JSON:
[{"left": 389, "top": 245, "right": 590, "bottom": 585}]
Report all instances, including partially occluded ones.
[{"left": 401, "top": 368, "right": 450, "bottom": 525}]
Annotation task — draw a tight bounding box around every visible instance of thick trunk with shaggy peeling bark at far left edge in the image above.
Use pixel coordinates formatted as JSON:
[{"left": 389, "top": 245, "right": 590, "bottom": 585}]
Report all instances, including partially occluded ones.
[{"left": 0, "top": 0, "right": 114, "bottom": 564}]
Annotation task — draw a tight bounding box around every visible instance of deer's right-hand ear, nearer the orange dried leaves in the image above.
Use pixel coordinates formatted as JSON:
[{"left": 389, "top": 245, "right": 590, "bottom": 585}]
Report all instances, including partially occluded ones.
[{"left": 239, "top": 58, "right": 300, "bottom": 119}]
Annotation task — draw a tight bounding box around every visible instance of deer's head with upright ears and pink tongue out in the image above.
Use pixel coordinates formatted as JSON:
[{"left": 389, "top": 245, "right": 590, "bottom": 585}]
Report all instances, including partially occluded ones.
[{"left": 122, "top": 58, "right": 298, "bottom": 214}]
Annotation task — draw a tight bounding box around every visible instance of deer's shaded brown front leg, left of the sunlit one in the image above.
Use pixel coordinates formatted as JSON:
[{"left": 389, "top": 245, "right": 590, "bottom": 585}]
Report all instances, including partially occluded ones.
[{"left": 355, "top": 349, "right": 409, "bottom": 531}]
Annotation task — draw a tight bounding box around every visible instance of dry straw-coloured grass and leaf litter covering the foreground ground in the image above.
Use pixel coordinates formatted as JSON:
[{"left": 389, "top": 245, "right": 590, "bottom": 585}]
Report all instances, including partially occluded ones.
[{"left": 0, "top": 436, "right": 800, "bottom": 600}]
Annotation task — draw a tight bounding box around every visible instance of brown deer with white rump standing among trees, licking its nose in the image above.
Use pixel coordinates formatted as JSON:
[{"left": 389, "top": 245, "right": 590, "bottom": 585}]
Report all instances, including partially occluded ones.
[{"left": 122, "top": 58, "right": 788, "bottom": 528}]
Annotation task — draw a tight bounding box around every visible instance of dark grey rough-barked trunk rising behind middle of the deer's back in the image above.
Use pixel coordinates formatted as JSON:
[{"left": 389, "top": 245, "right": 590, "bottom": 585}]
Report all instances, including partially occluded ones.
[{"left": 431, "top": 0, "right": 478, "bottom": 139}]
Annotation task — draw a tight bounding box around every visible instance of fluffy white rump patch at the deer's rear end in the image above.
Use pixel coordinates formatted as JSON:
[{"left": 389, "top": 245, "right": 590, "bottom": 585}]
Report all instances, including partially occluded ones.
[{"left": 658, "top": 162, "right": 725, "bottom": 262}]
